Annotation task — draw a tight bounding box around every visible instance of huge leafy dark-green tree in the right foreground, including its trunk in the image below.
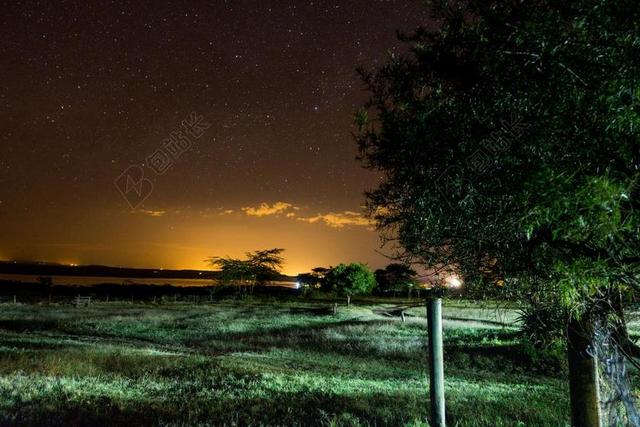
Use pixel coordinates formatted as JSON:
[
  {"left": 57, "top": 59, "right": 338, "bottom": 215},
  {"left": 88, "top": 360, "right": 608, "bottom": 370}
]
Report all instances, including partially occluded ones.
[{"left": 356, "top": 0, "right": 640, "bottom": 426}]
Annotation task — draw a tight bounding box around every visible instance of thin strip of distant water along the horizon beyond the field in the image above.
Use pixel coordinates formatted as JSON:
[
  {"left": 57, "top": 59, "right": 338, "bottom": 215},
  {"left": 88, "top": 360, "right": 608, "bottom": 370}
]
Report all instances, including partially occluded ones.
[{"left": 0, "top": 274, "right": 296, "bottom": 288}]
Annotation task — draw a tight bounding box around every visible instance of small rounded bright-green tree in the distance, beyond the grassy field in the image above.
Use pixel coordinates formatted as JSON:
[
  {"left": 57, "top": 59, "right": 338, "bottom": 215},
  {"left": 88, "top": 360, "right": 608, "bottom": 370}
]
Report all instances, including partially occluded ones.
[{"left": 325, "top": 262, "right": 376, "bottom": 305}]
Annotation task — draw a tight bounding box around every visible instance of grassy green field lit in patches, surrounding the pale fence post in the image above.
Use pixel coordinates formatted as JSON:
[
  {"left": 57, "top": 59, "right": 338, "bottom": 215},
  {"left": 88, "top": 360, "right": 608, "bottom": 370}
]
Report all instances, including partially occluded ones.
[{"left": 0, "top": 301, "right": 569, "bottom": 426}]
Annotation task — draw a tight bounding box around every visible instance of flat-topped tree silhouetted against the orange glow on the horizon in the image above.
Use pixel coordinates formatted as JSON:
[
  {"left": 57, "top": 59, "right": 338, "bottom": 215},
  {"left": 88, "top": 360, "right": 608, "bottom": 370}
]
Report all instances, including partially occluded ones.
[{"left": 208, "top": 248, "right": 284, "bottom": 290}]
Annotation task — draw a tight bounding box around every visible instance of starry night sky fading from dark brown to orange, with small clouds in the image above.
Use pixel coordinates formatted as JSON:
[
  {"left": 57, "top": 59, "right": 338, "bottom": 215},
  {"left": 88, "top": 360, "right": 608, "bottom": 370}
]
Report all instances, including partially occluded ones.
[{"left": 0, "top": 0, "right": 428, "bottom": 274}]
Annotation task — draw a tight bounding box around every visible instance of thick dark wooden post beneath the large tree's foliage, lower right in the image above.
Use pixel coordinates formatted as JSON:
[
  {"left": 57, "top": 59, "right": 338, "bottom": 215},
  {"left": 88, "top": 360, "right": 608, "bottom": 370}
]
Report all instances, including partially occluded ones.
[{"left": 567, "top": 319, "right": 601, "bottom": 427}]
